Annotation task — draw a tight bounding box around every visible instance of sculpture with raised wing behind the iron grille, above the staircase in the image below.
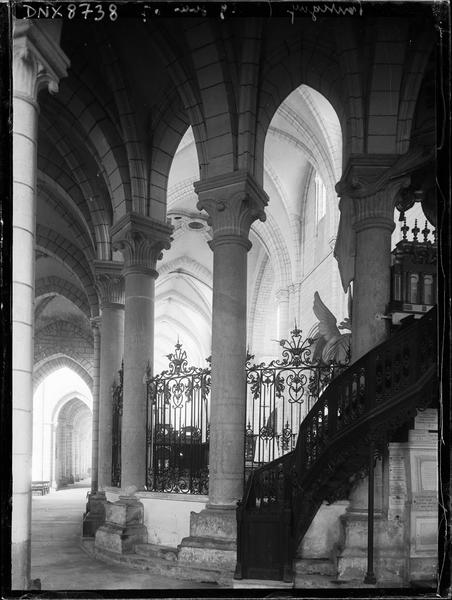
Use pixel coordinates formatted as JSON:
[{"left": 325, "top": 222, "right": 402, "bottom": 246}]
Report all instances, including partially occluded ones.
[{"left": 312, "top": 292, "right": 352, "bottom": 363}]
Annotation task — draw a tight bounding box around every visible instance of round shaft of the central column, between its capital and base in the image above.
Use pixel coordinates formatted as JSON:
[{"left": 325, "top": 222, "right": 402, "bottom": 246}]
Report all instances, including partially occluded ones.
[{"left": 209, "top": 236, "right": 249, "bottom": 506}]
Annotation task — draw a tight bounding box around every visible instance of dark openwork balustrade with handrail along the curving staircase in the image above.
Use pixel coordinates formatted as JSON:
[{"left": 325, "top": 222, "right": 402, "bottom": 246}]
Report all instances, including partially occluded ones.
[{"left": 240, "top": 306, "right": 437, "bottom": 509}]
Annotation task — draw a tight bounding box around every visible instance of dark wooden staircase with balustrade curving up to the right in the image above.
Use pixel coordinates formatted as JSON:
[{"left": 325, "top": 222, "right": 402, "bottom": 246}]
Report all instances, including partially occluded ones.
[{"left": 234, "top": 307, "right": 438, "bottom": 582}]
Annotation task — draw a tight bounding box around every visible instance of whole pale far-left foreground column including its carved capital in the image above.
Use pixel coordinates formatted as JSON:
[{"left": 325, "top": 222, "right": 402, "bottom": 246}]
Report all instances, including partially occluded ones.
[{"left": 11, "top": 20, "right": 69, "bottom": 590}]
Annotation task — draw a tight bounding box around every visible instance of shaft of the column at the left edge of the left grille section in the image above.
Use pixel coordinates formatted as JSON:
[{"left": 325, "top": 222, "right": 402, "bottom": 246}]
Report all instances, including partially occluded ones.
[{"left": 121, "top": 266, "right": 156, "bottom": 489}]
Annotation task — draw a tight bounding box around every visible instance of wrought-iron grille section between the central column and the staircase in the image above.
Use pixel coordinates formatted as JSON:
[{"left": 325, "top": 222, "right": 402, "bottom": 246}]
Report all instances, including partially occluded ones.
[{"left": 245, "top": 325, "right": 346, "bottom": 473}]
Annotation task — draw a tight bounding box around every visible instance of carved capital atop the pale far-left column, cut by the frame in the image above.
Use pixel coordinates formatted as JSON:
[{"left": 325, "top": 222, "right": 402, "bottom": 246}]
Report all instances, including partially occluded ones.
[{"left": 13, "top": 20, "right": 70, "bottom": 103}]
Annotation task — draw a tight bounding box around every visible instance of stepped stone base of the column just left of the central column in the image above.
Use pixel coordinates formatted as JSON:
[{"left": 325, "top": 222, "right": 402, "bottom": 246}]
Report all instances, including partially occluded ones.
[{"left": 94, "top": 496, "right": 148, "bottom": 554}]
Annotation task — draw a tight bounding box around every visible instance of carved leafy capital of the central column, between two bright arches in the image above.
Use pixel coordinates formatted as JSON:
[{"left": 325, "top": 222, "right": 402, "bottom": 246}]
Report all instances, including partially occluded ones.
[{"left": 194, "top": 171, "right": 268, "bottom": 241}]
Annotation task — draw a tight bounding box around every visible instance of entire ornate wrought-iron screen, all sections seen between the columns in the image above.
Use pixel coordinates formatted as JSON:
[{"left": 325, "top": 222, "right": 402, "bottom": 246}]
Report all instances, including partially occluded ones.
[{"left": 112, "top": 326, "right": 346, "bottom": 494}]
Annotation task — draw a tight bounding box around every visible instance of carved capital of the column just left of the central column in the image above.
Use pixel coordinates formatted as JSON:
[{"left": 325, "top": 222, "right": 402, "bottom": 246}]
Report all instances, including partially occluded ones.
[{"left": 111, "top": 213, "right": 173, "bottom": 277}]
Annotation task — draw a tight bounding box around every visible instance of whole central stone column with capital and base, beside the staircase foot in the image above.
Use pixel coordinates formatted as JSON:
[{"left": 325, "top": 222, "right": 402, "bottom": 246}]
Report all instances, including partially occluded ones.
[{"left": 180, "top": 171, "right": 268, "bottom": 568}]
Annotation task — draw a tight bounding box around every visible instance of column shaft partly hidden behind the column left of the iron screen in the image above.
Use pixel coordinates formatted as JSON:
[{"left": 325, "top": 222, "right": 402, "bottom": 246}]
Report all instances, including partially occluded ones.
[{"left": 98, "top": 304, "right": 124, "bottom": 489}]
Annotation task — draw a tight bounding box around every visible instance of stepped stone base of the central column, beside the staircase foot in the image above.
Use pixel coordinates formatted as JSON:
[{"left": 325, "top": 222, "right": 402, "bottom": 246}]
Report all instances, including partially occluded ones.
[{"left": 178, "top": 507, "right": 237, "bottom": 572}]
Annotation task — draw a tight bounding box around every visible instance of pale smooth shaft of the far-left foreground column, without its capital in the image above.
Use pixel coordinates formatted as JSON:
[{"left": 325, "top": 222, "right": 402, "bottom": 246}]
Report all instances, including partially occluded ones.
[{"left": 11, "top": 82, "right": 38, "bottom": 589}]
